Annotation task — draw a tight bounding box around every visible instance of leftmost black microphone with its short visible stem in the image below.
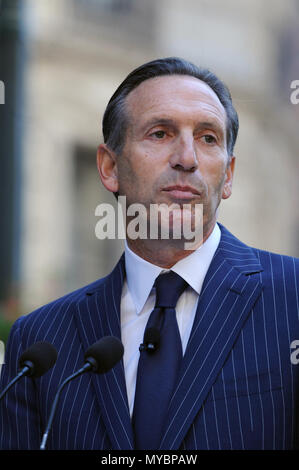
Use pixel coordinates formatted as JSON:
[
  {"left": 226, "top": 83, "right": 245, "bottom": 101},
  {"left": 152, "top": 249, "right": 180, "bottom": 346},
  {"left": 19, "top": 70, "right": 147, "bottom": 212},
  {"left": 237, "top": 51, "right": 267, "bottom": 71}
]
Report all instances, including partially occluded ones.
[{"left": 0, "top": 341, "right": 57, "bottom": 400}]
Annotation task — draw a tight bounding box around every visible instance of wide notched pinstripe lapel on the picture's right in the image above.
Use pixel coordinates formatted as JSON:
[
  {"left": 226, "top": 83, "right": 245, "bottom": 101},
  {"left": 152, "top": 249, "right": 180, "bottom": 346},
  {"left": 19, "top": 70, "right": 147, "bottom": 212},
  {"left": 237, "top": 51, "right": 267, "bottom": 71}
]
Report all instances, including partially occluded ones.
[{"left": 160, "top": 226, "right": 262, "bottom": 450}]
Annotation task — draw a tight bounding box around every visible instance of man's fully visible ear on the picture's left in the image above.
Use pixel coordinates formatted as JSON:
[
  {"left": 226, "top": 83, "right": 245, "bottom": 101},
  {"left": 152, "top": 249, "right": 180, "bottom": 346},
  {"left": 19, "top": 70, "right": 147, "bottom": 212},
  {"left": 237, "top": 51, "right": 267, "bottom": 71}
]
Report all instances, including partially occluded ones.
[{"left": 97, "top": 144, "right": 118, "bottom": 193}]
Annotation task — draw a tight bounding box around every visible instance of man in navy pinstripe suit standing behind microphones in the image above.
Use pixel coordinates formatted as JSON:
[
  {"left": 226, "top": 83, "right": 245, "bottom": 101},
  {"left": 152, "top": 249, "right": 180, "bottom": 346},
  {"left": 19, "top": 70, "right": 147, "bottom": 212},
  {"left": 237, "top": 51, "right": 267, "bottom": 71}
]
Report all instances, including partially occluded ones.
[{"left": 1, "top": 58, "right": 299, "bottom": 450}]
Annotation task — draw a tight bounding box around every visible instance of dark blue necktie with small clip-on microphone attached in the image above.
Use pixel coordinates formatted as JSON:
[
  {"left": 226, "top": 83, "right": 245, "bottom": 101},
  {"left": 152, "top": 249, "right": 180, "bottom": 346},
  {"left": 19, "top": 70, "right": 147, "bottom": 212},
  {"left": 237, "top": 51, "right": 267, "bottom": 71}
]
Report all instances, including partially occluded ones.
[{"left": 132, "top": 271, "right": 187, "bottom": 449}]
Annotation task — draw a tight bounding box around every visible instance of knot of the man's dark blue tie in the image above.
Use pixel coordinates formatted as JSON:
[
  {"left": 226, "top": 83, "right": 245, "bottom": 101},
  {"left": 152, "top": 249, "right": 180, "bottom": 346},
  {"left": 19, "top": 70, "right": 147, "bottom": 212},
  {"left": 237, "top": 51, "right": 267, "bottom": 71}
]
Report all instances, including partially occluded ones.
[{"left": 155, "top": 271, "right": 187, "bottom": 308}]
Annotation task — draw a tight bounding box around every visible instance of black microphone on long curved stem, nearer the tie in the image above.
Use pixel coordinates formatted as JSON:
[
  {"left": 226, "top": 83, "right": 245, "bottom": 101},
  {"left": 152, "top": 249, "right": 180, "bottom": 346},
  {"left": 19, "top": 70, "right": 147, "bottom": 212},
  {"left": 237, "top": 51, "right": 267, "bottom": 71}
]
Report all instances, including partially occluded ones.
[{"left": 40, "top": 336, "right": 124, "bottom": 450}]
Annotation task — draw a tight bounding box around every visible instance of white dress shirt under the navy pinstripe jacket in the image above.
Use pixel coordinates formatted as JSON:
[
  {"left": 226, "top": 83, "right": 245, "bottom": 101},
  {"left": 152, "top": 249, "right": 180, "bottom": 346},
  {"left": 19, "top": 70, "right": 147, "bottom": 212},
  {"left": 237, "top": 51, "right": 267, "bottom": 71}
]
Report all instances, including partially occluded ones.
[{"left": 121, "top": 224, "right": 221, "bottom": 415}]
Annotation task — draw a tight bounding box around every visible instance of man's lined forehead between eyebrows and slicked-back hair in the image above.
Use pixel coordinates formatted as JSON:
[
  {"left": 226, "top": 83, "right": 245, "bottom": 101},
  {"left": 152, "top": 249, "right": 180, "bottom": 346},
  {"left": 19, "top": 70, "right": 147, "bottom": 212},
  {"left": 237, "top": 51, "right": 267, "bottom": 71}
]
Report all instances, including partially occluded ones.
[{"left": 126, "top": 75, "right": 226, "bottom": 127}]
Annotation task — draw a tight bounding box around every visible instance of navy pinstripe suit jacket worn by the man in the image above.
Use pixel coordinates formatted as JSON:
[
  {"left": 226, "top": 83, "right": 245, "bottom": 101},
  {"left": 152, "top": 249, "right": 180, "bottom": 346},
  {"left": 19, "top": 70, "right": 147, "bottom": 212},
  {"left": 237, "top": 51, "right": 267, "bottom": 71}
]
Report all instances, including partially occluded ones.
[{"left": 0, "top": 226, "right": 299, "bottom": 450}]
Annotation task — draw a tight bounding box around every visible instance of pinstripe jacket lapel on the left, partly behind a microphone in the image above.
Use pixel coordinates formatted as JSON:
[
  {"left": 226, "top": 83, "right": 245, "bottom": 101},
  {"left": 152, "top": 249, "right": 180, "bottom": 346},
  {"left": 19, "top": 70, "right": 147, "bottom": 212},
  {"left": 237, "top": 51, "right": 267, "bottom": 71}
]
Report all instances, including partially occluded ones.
[{"left": 76, "top": 255, "right": 133, "bottom": 449}]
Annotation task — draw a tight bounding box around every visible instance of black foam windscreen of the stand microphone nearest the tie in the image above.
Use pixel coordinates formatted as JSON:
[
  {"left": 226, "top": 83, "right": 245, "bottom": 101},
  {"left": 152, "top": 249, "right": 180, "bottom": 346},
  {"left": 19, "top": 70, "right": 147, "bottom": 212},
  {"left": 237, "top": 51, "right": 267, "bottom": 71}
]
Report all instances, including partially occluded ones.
[{"left": 84, "top": 336, "right": 124, "bottom": 374}]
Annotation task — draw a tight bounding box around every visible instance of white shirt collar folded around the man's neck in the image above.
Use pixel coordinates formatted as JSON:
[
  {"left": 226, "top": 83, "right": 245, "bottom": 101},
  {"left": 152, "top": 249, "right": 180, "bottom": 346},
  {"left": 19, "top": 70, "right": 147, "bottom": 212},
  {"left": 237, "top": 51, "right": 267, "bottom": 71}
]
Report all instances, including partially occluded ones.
[{"left": 125, "top": 223, "right": 221, "bottom": 314}]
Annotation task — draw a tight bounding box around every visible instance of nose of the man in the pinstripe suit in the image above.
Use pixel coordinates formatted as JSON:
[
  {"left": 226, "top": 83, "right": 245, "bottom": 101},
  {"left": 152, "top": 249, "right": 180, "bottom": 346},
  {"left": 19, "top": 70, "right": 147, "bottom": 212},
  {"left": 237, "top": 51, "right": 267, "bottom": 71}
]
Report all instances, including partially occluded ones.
[{"left": 169, "top": 135, "right": 198, "bottom": 172}]
